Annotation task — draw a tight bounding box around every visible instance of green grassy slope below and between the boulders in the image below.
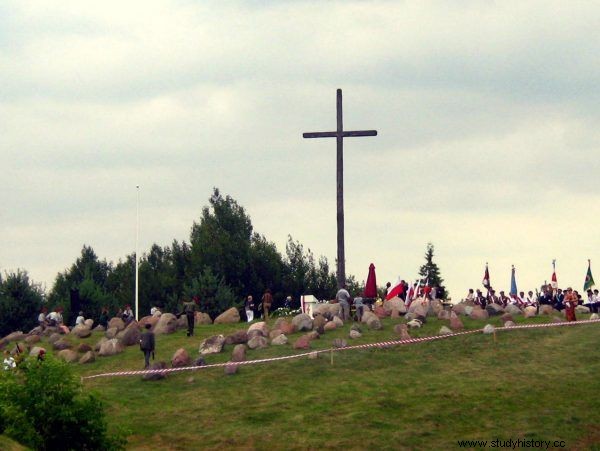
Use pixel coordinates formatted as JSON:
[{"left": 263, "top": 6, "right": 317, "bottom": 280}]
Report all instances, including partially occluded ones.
[{"left": 38, "top": 317, "right": 600, "bottom": 450}]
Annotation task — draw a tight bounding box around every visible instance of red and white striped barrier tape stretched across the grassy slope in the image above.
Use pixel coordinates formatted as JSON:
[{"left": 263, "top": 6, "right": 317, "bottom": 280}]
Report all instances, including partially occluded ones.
[{"left": 82, "top": 319, "right": 600, "bottom": 379}]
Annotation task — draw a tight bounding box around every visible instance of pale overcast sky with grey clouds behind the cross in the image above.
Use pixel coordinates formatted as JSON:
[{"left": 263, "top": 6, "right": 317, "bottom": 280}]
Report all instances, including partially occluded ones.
[{"left": 0, "top": 0, "right": 600, "bottom": 299}]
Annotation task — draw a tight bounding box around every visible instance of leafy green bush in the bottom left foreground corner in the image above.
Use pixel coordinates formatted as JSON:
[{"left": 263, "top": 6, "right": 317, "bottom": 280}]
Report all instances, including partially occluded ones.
[{"left": 0, "top": 357, "right": 125, "bottom": 450}]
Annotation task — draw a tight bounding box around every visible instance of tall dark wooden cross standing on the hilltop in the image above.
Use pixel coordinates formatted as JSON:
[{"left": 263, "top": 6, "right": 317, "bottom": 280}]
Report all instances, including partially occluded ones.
[{"left": 302, "top": 89, "right": 377, "bottom": 288}]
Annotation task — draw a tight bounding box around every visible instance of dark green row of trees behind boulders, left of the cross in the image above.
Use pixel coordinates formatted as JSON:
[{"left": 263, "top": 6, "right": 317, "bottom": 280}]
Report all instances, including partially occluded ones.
[{"left": 0, "top": 188, "right": 360, "bottom": 333}]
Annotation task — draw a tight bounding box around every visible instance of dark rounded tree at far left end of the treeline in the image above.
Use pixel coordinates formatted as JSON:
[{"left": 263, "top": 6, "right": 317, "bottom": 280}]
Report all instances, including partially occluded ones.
[{"left": 0, "top": 269, "right": 44, "bottom": 337}]
